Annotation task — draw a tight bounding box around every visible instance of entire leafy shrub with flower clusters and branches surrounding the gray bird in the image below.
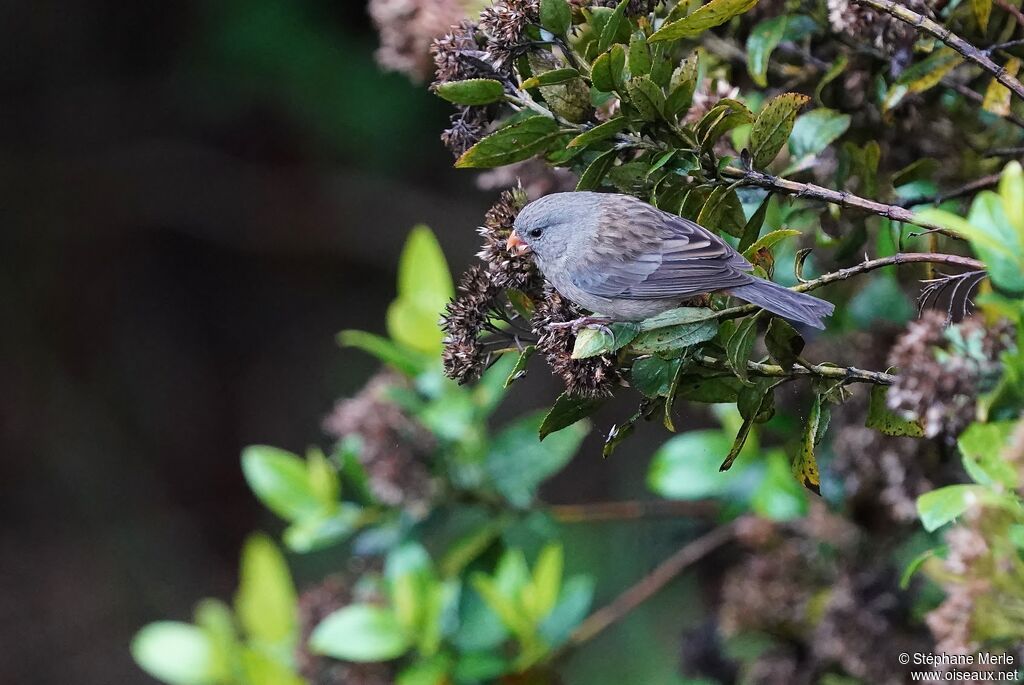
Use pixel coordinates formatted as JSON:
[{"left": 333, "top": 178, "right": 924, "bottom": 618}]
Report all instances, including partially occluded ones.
[{"left": 132, "top": 0, "right": 1024, "bottom": 685}]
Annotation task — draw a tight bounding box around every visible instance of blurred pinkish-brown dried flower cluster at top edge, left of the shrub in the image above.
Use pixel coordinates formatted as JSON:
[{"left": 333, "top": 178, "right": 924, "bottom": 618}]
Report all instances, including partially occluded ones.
[{"left": 368, "top": 0, "right": 466, "bottom": 82}]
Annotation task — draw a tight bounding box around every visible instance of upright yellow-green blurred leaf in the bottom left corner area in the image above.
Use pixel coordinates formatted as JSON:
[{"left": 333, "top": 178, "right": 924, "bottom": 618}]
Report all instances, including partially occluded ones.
[{"left": 234, "top": 533, "right": 298, "bottom": 648}]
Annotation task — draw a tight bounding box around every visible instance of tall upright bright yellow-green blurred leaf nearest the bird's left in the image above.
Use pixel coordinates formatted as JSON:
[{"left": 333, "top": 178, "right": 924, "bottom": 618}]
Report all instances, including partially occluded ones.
[{"left": 387, "top": 225, "right": 455, "bottom": 354}]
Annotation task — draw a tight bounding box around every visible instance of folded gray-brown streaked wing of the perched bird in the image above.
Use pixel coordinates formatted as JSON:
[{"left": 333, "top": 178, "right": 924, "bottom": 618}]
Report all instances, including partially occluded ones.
[{"left": 572, "top": 203, "right": 753, "bottom": 300}]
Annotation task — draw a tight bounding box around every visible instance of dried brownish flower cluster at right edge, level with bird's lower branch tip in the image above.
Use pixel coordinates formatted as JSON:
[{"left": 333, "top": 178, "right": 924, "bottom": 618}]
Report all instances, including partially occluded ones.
[{"left": 888, "top": 310, "right": 1014, "bottom": 437}]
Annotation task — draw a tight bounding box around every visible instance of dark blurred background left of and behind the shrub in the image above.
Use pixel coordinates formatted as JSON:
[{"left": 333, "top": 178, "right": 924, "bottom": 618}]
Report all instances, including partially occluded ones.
[{"left": 0, "top": 0, "right": 685, "bottom": 685}]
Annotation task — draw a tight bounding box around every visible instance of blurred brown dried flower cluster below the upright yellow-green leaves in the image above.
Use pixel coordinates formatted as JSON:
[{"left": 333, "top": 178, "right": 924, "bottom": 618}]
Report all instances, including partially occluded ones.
[{"left": 324, "top": 372, "right": 434, "bottom": 512}]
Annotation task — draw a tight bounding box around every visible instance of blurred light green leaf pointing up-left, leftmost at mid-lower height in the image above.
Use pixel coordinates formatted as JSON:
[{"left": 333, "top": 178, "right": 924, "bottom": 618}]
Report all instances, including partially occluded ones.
[{"left": 242, "top": 445, "right": 326, "bottom": 521}]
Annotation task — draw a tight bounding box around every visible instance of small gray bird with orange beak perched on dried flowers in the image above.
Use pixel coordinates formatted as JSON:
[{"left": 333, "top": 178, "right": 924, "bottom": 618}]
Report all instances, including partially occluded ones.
[{"left": 507, "top": 191, "right": 835, "bottom": 329}]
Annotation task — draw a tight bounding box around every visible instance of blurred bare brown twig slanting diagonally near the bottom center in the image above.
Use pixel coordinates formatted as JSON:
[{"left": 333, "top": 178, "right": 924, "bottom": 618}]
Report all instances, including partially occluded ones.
[{"left": 560, "top": 519, "right": 742, "bottom": 651}]
